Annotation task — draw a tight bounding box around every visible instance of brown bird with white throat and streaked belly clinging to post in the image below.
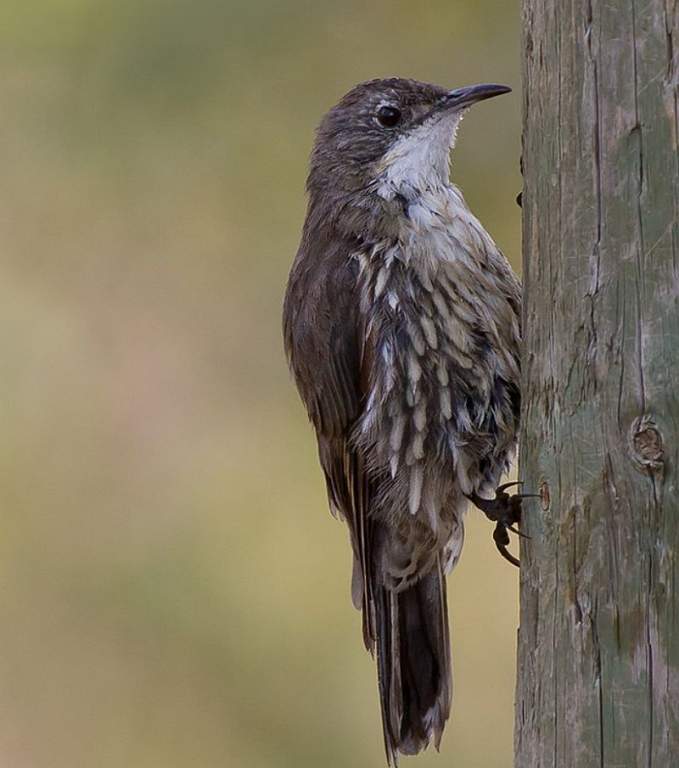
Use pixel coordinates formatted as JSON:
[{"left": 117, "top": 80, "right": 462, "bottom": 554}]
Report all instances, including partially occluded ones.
[{"left": 283, "top": 77, "right": 522, "bottom": 766}]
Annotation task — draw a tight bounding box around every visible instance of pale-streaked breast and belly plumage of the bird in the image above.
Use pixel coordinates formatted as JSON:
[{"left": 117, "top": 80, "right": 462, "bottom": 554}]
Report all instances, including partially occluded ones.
[{"left": 352, "top": 187, "right": 520, "bottom": 583}]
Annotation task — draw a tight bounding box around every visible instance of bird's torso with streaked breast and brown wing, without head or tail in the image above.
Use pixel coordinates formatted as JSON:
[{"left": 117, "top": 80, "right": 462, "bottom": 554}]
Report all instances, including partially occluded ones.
[{"left": 285, "top": 182, "right": 520, "bottom": 600}]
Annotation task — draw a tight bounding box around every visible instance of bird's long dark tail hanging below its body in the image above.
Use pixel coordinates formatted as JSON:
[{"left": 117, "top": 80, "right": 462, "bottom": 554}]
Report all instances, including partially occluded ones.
[{"left": 373, "top": 562, "right": 452, "bottom": 766}]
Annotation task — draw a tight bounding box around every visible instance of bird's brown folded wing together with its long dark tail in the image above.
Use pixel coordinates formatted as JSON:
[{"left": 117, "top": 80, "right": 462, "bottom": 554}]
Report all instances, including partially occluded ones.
[{"left": 284, "top": 218, "right": 452, "bottom": 764}]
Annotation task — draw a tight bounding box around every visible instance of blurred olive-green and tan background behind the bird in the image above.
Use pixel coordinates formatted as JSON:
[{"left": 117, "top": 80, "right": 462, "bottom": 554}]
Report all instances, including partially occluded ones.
[{"left": 0, "top": 0, "right": 520, "bottom": 768}]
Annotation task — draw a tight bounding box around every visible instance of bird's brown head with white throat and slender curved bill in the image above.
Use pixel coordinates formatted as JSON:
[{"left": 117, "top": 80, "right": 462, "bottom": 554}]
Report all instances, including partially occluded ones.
[{"left": 307, "top": 78, "right": 511, "bottom": 236}]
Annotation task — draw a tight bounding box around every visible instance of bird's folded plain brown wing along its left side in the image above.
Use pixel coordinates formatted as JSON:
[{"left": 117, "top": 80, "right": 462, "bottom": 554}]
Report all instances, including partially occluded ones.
[{"left": 283, "top": 234, "right": 375, "bottom": 651}]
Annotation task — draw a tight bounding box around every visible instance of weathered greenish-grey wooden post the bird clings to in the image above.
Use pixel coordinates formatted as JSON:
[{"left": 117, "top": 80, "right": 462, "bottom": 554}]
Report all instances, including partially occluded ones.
[{"left": 515, "top": 0, "right": 679, "bottom": 768}]
